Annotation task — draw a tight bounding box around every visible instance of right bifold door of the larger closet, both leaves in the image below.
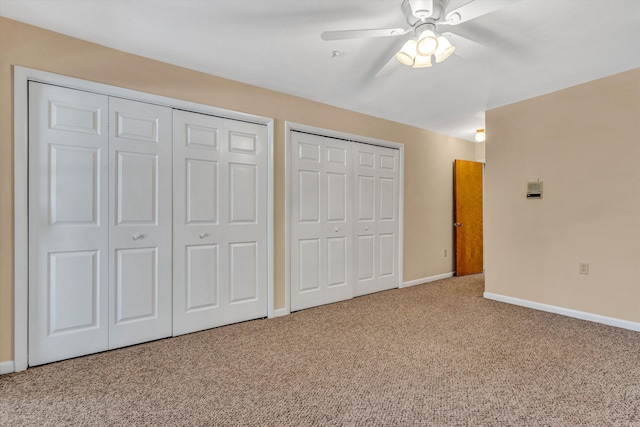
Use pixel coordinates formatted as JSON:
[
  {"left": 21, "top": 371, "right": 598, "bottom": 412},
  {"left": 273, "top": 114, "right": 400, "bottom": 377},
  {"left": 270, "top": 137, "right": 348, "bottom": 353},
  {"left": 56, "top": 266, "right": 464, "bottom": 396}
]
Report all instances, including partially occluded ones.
[{"left": 173, "top": 110, "right": 268, "bottom": 335}]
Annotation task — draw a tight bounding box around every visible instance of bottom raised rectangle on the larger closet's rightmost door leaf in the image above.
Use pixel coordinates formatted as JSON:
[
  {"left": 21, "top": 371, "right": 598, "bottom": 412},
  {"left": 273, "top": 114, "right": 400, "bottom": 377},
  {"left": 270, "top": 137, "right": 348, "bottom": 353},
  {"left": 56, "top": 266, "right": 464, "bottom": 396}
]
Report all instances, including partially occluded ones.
[{"left": 229, "top": 242, "right": 258, "bottom": 304}]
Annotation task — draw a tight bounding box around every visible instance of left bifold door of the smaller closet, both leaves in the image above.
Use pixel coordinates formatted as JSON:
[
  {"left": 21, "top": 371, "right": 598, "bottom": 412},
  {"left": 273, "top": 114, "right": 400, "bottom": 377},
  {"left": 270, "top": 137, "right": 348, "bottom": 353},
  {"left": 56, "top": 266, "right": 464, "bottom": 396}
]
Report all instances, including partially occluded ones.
[{"left": 290, "top": 131, "right": 353, "bottom": 311}]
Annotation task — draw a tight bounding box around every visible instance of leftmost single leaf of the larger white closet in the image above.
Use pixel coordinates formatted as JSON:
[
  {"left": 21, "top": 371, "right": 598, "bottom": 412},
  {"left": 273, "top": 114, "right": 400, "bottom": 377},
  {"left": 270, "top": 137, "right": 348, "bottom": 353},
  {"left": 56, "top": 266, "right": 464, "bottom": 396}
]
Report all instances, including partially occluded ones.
[{"left": 29, "top": 82, "right": 109, "bottom": 366}]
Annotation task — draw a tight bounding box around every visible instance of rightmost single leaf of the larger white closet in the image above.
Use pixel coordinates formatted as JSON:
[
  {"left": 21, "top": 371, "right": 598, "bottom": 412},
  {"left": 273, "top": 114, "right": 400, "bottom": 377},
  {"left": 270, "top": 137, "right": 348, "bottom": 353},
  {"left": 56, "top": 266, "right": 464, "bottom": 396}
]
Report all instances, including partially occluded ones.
[{"left": 219, "top": 119, "right": 268, "bottom": 326}]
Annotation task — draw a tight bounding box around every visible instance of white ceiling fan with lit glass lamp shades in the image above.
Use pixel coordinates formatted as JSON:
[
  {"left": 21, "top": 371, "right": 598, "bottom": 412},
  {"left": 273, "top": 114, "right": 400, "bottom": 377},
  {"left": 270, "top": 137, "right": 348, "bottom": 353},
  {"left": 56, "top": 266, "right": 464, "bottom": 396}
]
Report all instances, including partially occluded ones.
[{"left": 321, "top": 0, "right": 518, "bottom": 72}]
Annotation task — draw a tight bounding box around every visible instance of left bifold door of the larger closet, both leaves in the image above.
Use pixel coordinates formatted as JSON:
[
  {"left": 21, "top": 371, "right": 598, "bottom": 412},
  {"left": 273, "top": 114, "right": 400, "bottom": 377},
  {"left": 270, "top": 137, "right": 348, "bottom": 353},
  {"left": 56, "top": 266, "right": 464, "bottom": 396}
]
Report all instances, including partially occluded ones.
[{"left": 29, "top": 82, "right": 171, "bottom": 366}]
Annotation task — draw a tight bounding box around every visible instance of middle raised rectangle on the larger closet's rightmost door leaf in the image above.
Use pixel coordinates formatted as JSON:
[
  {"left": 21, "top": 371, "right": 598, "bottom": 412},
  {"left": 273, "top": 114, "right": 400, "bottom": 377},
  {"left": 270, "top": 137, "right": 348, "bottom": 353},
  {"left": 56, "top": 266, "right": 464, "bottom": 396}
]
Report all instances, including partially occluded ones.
[{"left": 229, "top": 163, "right": 258, "bottom": 224}]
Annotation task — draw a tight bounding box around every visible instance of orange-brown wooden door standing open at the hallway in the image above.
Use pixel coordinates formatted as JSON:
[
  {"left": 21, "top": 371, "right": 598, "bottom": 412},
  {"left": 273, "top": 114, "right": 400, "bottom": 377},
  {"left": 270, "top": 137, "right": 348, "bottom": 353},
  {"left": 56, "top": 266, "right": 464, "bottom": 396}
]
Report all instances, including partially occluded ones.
[{"left": 454, "top": 160, "right": 484, "bottom": 276}]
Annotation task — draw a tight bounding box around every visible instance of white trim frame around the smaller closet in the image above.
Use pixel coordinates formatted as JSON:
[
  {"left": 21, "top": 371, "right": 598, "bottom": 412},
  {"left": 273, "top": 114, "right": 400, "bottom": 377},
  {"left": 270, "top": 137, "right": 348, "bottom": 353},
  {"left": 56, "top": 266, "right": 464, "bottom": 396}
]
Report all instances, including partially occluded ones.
[{"left": 284, "top": 121, "right": 404, "bottom": 316}]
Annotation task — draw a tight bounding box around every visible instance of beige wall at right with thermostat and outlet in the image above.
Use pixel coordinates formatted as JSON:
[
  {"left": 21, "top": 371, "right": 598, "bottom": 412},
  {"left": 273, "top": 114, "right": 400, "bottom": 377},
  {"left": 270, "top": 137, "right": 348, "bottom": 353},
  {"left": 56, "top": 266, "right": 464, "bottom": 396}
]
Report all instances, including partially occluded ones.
[{"left": 485, "top": 69, "right": 640, "bottom": 322}]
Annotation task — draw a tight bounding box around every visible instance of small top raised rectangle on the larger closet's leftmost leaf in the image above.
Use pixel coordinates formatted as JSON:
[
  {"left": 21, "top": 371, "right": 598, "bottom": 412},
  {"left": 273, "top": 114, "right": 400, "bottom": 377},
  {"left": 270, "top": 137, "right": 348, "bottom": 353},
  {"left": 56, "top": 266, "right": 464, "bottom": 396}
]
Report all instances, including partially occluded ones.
[{"left": 49, "top": 101, "right": 101, "bottom": 135}]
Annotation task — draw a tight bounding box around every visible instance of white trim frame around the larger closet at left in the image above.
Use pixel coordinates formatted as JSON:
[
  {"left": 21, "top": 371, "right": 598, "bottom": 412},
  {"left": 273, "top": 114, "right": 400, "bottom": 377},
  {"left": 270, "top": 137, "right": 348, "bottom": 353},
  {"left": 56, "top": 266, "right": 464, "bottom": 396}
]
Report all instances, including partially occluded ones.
[{"left": 13, "top": 66, "right": 275, "bottom": 372}]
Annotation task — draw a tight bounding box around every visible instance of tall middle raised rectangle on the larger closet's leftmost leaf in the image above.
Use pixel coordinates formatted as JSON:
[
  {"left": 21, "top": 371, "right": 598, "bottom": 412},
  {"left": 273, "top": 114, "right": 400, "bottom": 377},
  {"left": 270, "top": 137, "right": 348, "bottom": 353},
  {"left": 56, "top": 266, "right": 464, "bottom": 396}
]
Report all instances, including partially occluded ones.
[{"left": 49, "top": 145, "right": 100, "bottom": 225}]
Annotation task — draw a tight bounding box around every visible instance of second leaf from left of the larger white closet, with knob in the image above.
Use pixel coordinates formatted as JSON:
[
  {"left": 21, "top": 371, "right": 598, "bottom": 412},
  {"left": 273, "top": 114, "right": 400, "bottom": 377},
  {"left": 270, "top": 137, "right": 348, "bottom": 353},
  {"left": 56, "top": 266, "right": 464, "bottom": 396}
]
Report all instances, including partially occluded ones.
[{"left": 109, "top": 98, "right": 172, "bottom": 348}]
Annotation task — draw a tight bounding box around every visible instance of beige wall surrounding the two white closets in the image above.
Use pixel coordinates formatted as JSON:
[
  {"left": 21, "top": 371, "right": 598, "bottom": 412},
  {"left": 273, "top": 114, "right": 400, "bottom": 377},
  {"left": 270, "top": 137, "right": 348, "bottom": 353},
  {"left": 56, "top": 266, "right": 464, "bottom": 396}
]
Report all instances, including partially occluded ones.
[{"left": 0, "top": 18, "right": 475, "bottom": 362}]
